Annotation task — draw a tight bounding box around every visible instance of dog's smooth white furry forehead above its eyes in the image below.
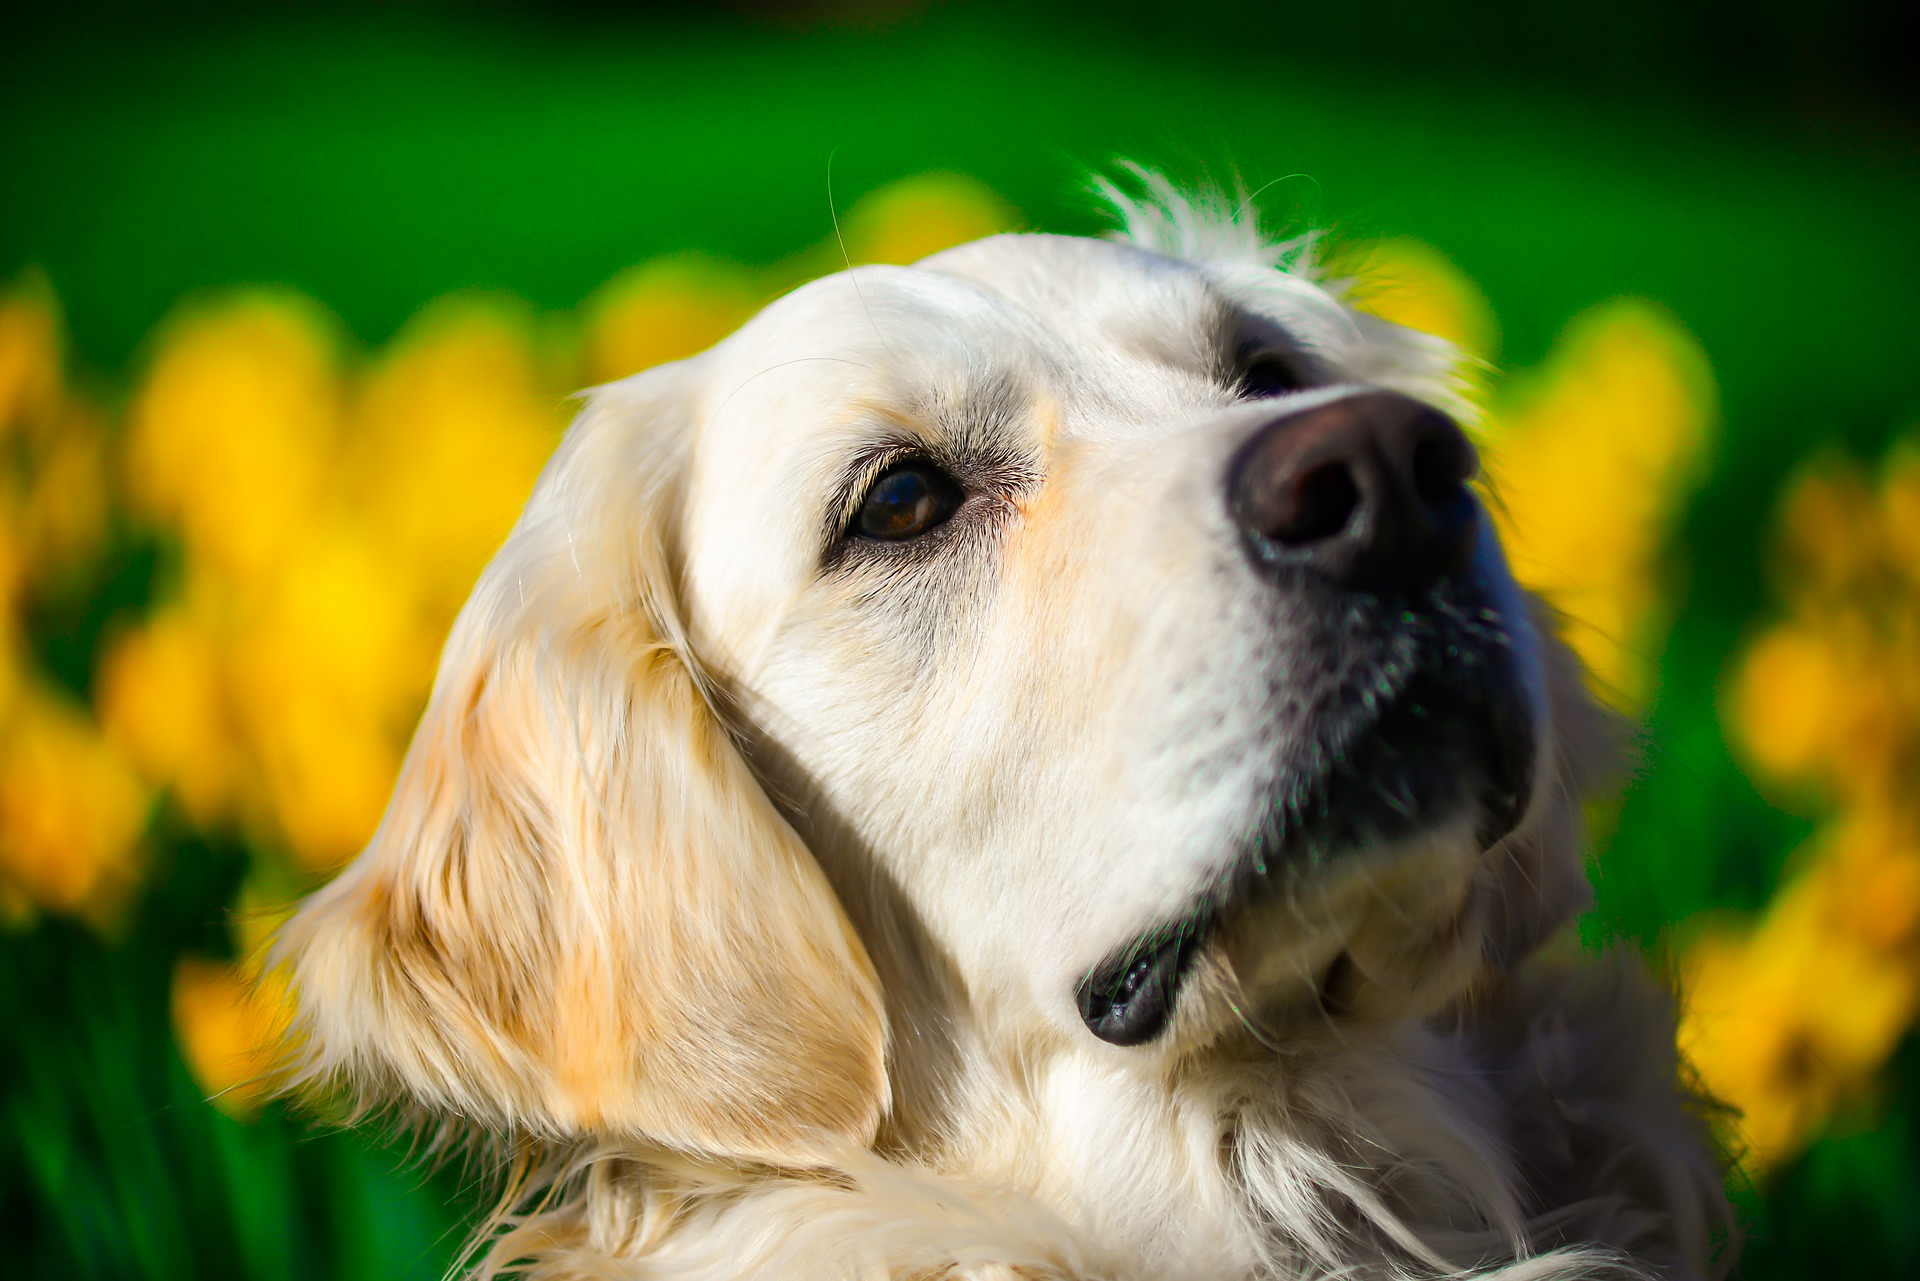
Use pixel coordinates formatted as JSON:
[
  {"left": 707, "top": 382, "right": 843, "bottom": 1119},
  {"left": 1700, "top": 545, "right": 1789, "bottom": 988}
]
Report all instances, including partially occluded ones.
[{"left": 708, "top": 234, "right": 1233, "bottom": 444}]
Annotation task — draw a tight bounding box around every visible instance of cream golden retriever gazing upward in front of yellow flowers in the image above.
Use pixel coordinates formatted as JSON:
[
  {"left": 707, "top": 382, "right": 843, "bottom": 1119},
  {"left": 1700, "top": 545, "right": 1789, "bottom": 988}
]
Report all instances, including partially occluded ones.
[{"left": 273, "top": 179, "right": 1730, "bottom": 1281}]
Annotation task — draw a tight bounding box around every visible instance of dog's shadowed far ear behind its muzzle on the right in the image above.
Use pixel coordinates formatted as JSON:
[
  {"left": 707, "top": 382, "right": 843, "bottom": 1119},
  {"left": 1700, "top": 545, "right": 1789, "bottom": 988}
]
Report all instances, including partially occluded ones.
[{"left": 1488, "top": 601, "right": 1624, "bottom": 968}]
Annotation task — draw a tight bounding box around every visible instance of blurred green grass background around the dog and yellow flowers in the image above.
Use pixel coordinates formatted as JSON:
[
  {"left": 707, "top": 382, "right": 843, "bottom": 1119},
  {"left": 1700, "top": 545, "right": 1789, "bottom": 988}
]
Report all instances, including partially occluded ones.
[{"left": 0, "top": 0, "right": 1920, "bottom": 1279}]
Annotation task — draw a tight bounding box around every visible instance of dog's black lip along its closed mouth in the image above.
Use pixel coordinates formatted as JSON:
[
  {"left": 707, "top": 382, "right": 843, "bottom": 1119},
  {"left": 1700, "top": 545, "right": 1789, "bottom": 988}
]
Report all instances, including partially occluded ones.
[{"left": 1075, "top": 576, "right": 1536, "bottom": 1045}]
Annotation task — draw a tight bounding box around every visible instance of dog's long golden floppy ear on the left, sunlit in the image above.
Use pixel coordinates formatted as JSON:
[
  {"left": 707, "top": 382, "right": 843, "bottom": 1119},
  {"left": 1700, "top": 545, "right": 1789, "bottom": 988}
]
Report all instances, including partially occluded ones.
[{"left": 269, "top": 367, "right": 887, "bottom": 1162}]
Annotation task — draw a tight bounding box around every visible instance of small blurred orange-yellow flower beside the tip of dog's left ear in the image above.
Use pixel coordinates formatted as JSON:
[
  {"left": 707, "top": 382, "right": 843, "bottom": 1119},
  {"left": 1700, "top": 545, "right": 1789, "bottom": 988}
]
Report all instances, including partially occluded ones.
[{"left": 173, "top": 956, "right": 286, "bottom": 1120}]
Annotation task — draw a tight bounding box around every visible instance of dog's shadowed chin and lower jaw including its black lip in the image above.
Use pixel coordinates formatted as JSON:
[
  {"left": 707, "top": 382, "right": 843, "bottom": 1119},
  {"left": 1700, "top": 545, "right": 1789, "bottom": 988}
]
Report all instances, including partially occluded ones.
[{"left": 1077, "top": 660, "right": 1538, "bottom": 1047}]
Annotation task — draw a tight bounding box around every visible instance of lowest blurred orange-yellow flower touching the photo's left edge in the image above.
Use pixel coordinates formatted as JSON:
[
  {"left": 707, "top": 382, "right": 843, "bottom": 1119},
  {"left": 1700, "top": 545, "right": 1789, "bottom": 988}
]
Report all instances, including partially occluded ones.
[{"left": 0, "top": 684, "right": 148, "bottom": 922}]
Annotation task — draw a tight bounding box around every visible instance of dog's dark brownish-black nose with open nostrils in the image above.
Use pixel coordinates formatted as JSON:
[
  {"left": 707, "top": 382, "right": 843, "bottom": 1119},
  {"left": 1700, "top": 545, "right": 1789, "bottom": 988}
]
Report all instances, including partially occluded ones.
[{"left": 1227, "top": 392, "right": 1478, "bottom": 592}]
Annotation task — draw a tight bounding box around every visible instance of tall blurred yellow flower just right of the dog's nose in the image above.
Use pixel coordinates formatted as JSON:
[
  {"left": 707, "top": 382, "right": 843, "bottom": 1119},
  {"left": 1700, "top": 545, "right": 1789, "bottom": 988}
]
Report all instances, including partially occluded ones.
[{"left": 1482, "top": 300, "right": 1715, "bottom": 703}]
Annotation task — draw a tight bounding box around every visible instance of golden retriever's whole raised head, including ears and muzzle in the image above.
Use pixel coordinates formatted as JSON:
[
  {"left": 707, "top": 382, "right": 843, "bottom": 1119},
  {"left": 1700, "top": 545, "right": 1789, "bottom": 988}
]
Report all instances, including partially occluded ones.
[{"left": 278, "top": 193, "right": 1596, "bottom": 1162}]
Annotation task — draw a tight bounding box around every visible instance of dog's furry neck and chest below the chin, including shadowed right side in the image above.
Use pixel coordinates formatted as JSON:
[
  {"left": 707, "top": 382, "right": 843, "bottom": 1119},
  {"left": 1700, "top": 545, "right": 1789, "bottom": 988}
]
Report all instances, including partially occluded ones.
[{"left": 881, "top": 948, "right": 1726, "bottom": 1277}]
